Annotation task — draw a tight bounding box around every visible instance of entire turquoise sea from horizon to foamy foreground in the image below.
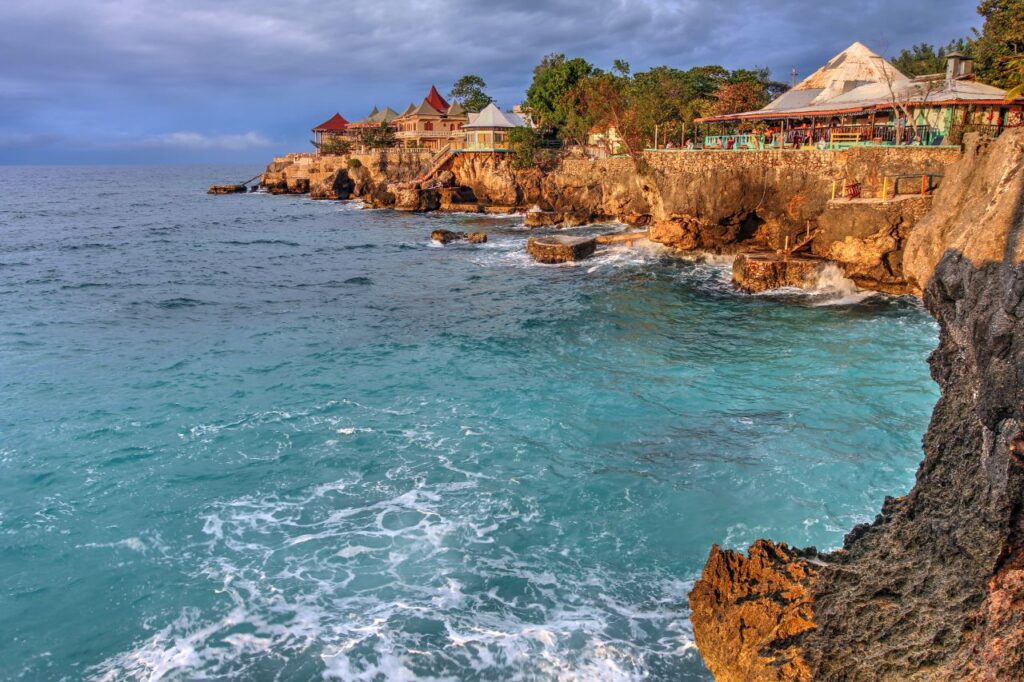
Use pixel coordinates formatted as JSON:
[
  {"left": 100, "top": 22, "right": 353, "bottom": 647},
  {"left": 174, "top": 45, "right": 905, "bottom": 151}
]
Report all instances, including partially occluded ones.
[{"left": 0, "top": 167, "right": 937, "bottom": 680}]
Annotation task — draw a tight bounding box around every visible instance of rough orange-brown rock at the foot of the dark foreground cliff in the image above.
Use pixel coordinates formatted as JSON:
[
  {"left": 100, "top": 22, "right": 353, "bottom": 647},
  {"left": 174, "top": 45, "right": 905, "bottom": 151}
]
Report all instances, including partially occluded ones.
[{"left": 690, "top": 540, "right": 817, "bottom": 682}]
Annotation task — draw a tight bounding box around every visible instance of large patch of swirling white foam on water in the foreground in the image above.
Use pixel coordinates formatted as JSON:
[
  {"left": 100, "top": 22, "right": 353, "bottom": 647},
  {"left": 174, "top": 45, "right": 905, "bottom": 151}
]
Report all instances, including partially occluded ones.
[{"left": 90, "top": 466, "right": 692, "bottom": 681}]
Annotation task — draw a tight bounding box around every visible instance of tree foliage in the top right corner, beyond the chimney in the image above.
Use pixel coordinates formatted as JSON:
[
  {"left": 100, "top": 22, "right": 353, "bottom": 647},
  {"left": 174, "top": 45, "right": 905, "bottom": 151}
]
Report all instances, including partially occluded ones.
[{"left": 975, "top": 0, "right": 1024, "bottom": 88}]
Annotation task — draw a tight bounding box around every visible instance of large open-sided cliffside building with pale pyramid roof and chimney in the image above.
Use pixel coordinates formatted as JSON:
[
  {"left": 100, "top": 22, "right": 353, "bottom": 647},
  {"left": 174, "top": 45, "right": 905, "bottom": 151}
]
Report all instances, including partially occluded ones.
[{"left": 696, "top": 43, "right": 1024, "bottom": 148}]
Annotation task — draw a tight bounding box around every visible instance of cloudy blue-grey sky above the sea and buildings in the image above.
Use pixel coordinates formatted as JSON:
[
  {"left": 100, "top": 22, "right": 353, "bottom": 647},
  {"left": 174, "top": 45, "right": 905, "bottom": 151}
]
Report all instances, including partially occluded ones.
[{"left": 0, "top": 0, "right": 981, "bottom": 164}]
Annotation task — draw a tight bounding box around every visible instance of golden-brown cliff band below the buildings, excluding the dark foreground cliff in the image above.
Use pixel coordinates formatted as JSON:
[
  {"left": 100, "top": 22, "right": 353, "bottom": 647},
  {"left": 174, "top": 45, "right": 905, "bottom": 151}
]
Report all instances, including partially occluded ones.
[{"left": 261, "top": 147, "right": 959, "bottom": 294}]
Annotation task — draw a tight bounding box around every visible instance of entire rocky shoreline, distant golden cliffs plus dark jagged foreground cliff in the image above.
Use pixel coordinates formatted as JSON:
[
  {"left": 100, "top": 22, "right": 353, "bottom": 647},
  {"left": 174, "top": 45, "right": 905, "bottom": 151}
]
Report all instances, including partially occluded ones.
[{"left": 263, "top": 131, "right": 1024, "bottom": 681}]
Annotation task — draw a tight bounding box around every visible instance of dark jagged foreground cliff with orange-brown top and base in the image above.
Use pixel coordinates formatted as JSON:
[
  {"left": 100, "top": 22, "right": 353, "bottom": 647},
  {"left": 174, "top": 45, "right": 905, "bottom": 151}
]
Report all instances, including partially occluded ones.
[{"left": 690, "top": 131, "right": 1024, "bottom": 680}]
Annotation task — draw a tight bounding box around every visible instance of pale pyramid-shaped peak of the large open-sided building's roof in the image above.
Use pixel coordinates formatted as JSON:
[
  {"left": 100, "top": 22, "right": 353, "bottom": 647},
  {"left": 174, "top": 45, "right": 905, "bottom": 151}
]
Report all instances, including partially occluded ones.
[{"left": 762, "top": 43, "right": 907, "bottom": 112}]
